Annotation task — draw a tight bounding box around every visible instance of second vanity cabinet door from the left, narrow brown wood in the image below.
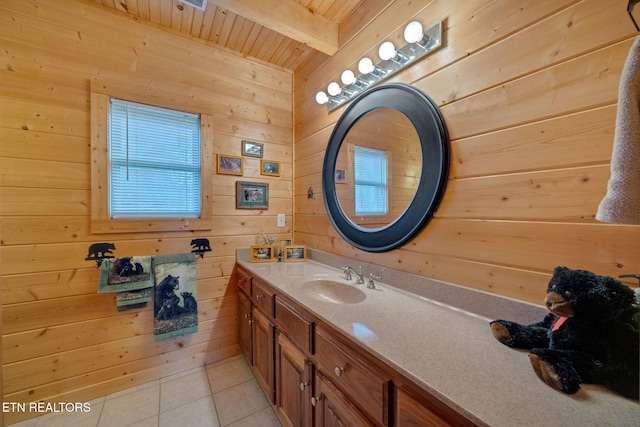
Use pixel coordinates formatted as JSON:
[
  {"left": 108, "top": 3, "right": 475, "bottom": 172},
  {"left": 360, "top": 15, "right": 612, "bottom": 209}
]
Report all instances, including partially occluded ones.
[{"left": 252, "top": 306, "right": 275, "bottom": 403}]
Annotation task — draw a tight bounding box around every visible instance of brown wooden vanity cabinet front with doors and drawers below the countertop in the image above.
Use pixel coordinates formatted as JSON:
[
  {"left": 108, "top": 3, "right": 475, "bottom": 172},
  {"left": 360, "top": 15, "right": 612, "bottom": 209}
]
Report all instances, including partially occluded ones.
[{"left": 234, "top": 267, "right": 474, "bottom": 427}]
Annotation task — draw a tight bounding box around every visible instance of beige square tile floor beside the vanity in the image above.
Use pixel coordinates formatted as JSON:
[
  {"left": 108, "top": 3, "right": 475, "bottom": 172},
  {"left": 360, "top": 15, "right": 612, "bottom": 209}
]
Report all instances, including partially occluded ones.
[{"left": 6, "top": 356, "right": 281, "bottom": 427}]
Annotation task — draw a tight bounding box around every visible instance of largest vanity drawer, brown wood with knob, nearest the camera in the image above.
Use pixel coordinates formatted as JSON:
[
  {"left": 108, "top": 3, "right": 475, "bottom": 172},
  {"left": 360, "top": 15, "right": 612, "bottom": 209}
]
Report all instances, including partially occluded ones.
[{"left": 315, "top": 327, "right": 389, "bottom": 425}]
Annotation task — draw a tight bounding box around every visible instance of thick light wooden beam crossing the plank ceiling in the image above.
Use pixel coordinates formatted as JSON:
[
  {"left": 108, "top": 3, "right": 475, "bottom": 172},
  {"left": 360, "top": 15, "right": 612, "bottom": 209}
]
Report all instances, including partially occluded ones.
[{"left": 210, "top": 0, "right": 338, "bottom": 56}]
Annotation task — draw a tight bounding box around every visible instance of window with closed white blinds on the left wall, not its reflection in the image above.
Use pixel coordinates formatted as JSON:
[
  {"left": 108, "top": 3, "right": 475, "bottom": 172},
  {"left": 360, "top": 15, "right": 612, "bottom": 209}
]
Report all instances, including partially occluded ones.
[{"left": 108, "top": 98, "right": 201, "bottom": 218}]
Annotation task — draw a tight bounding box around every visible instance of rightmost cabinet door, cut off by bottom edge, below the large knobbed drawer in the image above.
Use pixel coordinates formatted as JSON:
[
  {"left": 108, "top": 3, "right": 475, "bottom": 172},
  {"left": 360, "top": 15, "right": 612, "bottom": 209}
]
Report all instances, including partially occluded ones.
[{"left": 312, "top": 373, "right": 373, "bottom": 427}]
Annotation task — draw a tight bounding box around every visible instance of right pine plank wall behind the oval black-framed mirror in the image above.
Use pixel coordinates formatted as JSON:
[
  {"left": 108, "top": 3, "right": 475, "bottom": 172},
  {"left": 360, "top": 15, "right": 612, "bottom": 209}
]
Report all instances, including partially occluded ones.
[{"left": 294, "top": 0, "right": 640, "bottom": 304}]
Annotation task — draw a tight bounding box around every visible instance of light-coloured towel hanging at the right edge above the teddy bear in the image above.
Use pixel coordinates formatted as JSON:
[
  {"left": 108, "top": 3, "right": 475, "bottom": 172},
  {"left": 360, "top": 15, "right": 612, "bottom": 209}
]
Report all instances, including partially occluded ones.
[{"left": 596, "top": 37, "right": 640, "bottom": 224}]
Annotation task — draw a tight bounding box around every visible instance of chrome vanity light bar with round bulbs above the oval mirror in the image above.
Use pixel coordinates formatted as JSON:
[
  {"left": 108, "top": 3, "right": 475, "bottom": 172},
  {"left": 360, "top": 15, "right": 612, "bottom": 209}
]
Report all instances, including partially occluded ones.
[{"left": 316, "top": 21, "right": 442, "bottom": 111}]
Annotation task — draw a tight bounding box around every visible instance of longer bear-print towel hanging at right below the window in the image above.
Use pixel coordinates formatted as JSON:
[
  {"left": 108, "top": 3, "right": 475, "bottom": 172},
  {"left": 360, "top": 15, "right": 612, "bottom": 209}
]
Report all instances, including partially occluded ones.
[{"left": 153, "top": 253, "right": 198, "bottom": 341}]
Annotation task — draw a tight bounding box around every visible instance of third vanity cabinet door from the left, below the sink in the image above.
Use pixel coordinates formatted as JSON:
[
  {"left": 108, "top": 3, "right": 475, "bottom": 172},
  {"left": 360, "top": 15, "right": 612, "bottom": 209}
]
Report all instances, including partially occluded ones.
[{"left": 276, "top": 332, "right": 313, "bottom": 427}]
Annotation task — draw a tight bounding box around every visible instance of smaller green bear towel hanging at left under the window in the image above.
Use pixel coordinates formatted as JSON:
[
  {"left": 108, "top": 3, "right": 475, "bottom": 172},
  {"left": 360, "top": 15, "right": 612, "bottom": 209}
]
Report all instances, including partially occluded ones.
[{"left": 98, "top": 256, "right": 153, "bottom": 293}]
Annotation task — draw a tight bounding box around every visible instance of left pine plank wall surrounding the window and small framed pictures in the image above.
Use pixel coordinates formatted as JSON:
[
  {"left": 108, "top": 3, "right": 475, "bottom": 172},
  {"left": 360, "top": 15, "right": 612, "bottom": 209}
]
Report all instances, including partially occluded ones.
[{"left": 0, "top": 0, "right": 293, "bottom": 423}]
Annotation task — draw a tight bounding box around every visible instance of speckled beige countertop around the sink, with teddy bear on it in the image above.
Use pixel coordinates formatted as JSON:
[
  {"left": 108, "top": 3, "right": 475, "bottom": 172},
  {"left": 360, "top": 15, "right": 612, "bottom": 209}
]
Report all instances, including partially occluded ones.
[{"left": 238, "top": 260, "right": 640, "bottom": 427}]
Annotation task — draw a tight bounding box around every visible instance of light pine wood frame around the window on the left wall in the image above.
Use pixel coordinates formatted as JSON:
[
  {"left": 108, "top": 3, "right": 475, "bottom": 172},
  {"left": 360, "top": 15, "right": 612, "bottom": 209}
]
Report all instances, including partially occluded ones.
[{"left": 91, "top": 81, "right": 214, "bottom": 233}]
